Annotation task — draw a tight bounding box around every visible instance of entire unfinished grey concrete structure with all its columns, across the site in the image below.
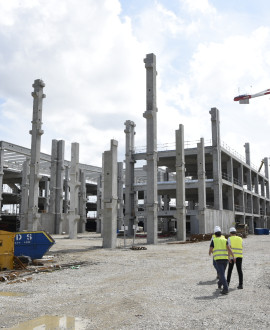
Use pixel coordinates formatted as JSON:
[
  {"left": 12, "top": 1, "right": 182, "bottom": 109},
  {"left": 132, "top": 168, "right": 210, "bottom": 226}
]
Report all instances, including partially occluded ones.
[{"left": 0, "top": 54, "right": 270, "bottom": 248}]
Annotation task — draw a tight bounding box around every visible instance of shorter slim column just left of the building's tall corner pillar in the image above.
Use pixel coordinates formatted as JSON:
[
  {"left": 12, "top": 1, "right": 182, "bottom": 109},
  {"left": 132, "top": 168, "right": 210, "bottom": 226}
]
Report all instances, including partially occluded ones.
[{"left": 197, "top": 138, "right": 206, "bottom": 234}]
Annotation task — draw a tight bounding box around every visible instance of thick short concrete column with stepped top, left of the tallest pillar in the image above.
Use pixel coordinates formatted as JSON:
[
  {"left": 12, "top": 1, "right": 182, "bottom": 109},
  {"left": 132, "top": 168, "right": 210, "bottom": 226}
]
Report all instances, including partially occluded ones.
[{"left": 103, "top": 140, "right": 118, "bottom": 249}]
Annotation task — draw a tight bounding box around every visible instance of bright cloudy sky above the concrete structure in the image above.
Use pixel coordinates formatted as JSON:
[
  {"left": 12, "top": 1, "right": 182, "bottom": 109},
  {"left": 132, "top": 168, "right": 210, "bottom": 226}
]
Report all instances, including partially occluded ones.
[{"left": 0, "top": 0, "right": 270, "bottom": 173}]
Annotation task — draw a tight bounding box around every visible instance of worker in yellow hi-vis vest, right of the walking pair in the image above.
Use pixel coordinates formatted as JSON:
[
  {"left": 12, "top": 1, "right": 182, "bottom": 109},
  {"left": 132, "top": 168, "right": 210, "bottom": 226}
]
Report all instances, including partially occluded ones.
[{"left": 227, "top": 227, "right": 243, "bottom": 289}]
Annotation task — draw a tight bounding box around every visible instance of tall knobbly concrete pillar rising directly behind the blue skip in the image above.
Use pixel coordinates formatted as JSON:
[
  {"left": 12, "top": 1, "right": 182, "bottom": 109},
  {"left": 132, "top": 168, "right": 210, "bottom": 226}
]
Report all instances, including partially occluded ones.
[{"left": 28, "top": 79, "right": 46, "bottom": 230}]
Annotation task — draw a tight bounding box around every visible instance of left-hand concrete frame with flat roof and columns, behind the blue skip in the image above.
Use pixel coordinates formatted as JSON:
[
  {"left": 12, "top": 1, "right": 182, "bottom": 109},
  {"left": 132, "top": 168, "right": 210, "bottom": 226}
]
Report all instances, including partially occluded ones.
[{"left": 0, "top": 79, "right": 102, "bottom": 238}]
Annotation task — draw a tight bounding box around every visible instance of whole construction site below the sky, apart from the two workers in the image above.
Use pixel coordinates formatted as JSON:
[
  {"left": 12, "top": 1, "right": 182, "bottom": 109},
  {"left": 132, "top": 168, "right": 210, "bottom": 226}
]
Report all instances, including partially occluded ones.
[{"left": 0, "top": 54, "right": 270, "bottom": 329}]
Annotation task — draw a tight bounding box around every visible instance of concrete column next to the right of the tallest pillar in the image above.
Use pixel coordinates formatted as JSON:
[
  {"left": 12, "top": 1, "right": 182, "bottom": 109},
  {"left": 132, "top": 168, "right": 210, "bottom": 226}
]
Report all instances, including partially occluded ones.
[{"left": 175, "top": 124, "right": 186, "bottom": 241}]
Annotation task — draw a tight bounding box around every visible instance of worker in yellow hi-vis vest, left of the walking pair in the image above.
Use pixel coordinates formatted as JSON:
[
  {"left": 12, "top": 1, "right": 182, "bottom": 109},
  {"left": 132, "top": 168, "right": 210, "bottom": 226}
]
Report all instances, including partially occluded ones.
[{"left": 209, "top": 228, "right": 234, "bottom": 294}]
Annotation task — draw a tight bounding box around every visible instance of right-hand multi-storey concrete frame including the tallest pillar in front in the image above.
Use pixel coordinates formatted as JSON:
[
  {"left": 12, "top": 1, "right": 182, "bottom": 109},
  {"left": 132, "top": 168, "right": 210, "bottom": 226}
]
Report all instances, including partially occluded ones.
[{"left": 125, "top": 54, "right": 270, "bottom": 244}]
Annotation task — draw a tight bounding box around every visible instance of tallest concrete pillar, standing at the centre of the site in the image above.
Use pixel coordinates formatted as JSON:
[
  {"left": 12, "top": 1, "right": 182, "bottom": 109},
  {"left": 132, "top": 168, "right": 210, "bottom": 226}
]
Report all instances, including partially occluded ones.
[{"left": 143, "top": 54, "right": 158, "bottom": 244}]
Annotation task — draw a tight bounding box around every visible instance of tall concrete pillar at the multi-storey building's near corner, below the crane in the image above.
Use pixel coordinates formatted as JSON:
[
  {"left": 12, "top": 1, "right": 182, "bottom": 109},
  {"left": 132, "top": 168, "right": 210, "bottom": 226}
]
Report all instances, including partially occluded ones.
[{"left": 209, "top": 108, "right": 223, "bottom": 210}]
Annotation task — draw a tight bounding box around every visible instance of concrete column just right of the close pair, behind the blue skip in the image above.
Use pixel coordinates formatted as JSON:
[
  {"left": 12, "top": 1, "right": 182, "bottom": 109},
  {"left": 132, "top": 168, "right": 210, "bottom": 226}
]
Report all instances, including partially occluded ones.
[{"left": 68, "top": 142, "right": 81, "bottom": 239}]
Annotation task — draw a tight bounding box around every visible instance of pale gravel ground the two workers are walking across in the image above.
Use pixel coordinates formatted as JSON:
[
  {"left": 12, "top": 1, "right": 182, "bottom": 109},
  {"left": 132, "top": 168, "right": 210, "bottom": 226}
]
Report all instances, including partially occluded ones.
[{"left": 0, "top": 233, "right": 270, "bottom": 329}]
